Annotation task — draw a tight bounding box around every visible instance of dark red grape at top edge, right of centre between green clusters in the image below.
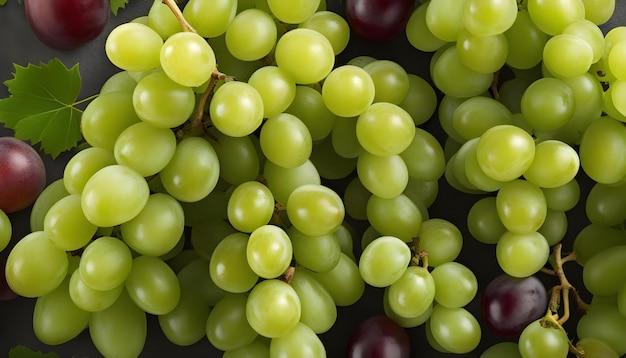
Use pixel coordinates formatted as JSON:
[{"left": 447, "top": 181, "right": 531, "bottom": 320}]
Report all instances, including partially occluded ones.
[{"left": 346, "top": 0, "right": 415, "bottom": 41}]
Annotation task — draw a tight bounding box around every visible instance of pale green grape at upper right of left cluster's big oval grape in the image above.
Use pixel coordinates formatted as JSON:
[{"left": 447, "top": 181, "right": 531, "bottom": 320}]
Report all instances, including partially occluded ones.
[{"left": 113, "top": 122, "right": 176, "bottom": 177}]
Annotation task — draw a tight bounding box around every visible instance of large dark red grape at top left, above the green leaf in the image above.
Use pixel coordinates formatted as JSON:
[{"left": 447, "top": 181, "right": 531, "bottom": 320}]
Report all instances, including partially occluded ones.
[{"left": 24, "top": 0, "right": 111, "bottom": 50}]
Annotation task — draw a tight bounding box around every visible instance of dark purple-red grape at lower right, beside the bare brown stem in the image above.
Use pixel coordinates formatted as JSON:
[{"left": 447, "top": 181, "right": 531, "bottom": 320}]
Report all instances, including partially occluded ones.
[{"left": 481, "top": 274, "right": 548, "bottom": 337}]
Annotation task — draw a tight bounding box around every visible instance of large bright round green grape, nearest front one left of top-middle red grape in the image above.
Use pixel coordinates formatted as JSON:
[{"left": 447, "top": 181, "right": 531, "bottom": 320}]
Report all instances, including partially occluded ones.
[{"left": 274, "top": 28, "right": 335, "bottom": 84}]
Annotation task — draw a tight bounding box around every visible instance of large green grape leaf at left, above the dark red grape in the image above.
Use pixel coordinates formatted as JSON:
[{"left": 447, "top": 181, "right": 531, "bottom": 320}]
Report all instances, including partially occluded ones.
[{"left": 0, "top": 58, "right": 82, "bottom": 158}]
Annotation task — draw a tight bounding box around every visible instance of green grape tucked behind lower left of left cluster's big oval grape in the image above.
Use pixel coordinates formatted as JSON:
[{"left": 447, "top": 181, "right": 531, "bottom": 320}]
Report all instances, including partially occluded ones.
[{"left": 43, "top": 194, "right": 98, "bottom": 251}]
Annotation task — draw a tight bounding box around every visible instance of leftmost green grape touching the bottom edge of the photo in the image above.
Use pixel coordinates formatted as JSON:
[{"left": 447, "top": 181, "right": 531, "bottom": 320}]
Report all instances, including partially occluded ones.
[{"left": 89, "top": 292, "right": 148, "bottom": 357}]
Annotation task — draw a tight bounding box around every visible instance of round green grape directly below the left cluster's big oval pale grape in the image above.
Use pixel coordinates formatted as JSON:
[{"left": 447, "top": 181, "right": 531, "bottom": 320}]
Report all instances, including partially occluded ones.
[{"left": 78, "top": 236, "right": 133, "bottom": 291}]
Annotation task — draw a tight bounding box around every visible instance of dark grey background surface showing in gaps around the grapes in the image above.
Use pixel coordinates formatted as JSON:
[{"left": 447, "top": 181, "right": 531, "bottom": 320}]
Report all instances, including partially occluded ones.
[{"left": 0, "top": 0, "right": 626, "bottom": 358}]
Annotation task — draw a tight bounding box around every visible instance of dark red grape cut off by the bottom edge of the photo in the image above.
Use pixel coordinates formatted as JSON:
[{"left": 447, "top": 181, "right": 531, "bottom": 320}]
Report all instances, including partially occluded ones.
[{"left": 346, "top": 315, "right": 411, "bottom": 358}]
